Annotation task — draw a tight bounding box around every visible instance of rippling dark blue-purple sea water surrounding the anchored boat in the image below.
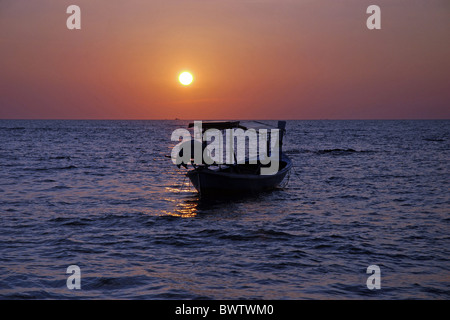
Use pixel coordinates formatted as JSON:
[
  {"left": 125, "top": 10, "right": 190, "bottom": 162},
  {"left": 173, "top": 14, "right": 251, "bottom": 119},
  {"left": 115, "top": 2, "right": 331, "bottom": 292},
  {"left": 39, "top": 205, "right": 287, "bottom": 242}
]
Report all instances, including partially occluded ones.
[{"left": 0, "top": 120, "right": 450, "bottom": 299}]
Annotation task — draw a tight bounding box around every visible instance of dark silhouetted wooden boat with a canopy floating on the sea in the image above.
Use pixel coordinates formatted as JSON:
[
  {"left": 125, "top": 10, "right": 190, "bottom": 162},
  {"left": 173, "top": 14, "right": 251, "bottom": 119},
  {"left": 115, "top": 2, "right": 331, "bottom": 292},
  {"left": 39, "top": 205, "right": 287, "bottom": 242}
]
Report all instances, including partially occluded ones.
[{"left": 171, "top": 121, "right": 292, "bottom": 197}]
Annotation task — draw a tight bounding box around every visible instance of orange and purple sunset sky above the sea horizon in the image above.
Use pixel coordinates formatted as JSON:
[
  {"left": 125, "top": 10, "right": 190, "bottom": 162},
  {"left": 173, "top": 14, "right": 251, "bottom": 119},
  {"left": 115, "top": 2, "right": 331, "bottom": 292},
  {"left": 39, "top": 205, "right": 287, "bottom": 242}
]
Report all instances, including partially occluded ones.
[{"left": 0, "top": 0, "right": 450, "bottom": 120}]
